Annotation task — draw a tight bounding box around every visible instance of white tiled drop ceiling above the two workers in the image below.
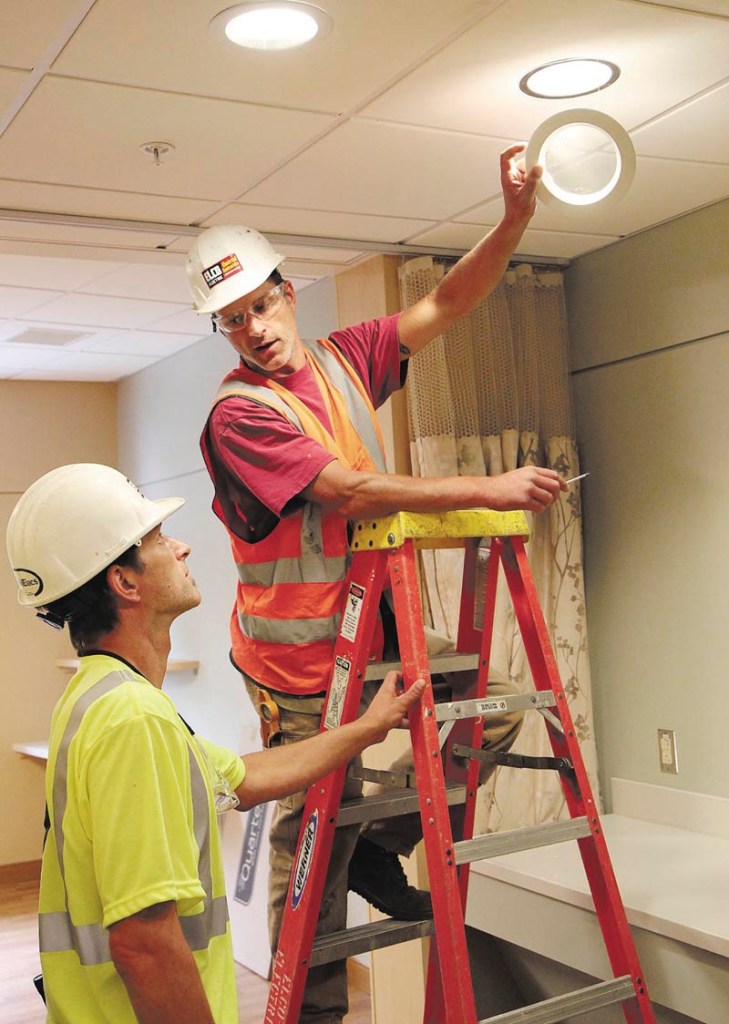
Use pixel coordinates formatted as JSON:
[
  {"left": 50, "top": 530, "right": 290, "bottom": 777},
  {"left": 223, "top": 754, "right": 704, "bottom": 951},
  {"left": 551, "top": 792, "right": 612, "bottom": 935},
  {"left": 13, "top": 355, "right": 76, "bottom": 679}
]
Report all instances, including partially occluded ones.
[{"left": 0, "top": 0, "right": 729, "bottom": 380}]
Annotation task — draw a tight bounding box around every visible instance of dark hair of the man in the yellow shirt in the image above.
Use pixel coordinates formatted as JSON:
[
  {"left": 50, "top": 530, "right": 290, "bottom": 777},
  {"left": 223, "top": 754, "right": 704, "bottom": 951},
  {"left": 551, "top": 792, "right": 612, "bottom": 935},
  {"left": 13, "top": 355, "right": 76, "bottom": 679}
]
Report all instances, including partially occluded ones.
[{"left": 47, "top": 545, "right": 141, "bottom": 654}]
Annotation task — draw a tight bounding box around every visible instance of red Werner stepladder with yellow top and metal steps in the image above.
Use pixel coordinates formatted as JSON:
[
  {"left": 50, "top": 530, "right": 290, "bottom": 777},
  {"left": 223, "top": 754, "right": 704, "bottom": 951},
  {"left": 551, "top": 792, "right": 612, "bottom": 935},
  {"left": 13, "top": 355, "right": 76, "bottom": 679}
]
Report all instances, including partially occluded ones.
[{"left": 265, "top": 510, "right": 655, "bottom": 1024}]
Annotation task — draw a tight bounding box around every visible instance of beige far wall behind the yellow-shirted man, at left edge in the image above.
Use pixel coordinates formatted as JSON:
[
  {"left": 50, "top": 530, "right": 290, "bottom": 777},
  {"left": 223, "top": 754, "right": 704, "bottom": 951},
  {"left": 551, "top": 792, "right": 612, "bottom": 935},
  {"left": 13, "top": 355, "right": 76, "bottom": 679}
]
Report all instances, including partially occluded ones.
[{"left": 0, "top": 381, "right": 117, "bottom": 864}]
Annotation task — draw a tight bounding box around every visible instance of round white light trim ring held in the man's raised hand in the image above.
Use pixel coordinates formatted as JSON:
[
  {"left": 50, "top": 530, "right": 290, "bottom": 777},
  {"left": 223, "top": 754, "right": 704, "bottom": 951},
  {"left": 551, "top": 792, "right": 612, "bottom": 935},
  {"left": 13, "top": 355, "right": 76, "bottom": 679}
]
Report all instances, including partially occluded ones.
[{"left": 524, "top": 110, "right": 636, "bottom": 210}]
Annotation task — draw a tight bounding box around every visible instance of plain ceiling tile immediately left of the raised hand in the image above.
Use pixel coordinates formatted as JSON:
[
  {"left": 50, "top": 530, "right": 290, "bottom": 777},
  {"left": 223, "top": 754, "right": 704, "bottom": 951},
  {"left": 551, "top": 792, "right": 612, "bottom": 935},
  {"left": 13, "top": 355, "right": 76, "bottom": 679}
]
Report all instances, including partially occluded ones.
[{"left": 241, "top": 121, "right": 509, "bottom": 220}]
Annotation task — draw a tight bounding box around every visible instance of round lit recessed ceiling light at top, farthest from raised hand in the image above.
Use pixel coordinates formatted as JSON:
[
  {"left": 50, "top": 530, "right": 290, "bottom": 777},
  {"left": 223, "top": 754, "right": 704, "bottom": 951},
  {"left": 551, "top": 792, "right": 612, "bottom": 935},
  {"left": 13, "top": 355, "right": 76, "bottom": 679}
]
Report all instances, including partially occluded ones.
[{"left": 209, "top": 0, "right": 332, "bottom": 50}]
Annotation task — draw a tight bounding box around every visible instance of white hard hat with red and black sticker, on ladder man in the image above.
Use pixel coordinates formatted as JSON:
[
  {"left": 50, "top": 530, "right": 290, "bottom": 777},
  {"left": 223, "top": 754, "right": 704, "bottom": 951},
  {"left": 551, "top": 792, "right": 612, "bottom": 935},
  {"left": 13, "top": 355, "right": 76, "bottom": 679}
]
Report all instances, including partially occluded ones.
[{"left": 186, "top": 225, "right": 285, "bottom": 313}]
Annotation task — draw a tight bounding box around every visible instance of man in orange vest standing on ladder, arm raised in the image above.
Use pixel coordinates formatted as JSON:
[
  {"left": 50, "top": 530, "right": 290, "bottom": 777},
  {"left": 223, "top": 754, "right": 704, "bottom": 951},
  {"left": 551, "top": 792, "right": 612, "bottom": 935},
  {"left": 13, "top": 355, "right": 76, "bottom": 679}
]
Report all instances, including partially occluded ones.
[{"left": 187, "top": 145, "right": 566, "bottom": 1024}]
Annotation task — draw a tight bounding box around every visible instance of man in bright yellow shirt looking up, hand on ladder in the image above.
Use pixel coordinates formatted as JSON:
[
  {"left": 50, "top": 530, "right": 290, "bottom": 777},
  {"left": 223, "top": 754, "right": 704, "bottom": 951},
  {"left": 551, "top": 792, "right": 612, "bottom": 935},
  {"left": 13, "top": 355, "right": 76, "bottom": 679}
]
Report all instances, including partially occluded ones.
[{"left": 7, "top": 464, "right": 424, "bottom": 1024}]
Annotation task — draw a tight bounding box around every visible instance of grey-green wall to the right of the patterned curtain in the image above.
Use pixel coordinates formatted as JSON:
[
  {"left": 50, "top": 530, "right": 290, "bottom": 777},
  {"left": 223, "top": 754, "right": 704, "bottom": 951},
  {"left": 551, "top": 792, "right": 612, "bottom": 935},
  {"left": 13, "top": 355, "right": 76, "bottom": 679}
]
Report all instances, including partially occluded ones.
[{"left": 566, "top": 203, "right": 729, "bottom": 798}]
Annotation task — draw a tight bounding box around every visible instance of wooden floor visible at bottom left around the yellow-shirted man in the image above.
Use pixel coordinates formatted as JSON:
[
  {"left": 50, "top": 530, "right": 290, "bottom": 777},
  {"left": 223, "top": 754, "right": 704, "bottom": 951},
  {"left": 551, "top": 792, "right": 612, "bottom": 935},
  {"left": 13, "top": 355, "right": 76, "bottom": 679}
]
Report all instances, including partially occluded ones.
[{"left": 0, "top": 881, "right": 371, "bottom": 1024}]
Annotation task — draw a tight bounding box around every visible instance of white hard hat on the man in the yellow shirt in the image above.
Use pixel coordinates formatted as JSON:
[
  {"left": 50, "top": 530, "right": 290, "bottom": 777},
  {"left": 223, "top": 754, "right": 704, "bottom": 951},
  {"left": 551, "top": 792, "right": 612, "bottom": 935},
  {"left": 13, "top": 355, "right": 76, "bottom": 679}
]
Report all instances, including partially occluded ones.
[{"left": 6, "top": 463, "right": 184, "bottom": 607}]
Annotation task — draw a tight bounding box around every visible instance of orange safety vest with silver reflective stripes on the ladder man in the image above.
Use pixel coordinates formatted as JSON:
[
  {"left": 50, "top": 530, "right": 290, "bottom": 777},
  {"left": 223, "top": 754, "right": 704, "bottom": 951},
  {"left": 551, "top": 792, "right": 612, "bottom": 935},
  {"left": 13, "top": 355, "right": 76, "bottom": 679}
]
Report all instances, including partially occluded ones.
[{"left": 213, "top": 338, "right": 385, "bottom": 695}]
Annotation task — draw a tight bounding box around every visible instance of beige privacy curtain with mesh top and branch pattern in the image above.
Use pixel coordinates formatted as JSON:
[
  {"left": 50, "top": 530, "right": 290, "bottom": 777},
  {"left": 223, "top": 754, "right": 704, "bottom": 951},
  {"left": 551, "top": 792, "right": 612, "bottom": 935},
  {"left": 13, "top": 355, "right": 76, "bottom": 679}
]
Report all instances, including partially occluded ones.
[{"left": 400, "top": 257, "right": 599, "bottom": 833}]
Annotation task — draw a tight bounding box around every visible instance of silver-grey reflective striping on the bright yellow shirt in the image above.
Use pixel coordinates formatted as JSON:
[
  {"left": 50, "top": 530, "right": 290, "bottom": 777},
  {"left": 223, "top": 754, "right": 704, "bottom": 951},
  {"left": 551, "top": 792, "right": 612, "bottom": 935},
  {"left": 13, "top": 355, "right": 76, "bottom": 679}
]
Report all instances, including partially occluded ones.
[{"left": 38, "top": 669, "right": 228, "bottom": 967}]
